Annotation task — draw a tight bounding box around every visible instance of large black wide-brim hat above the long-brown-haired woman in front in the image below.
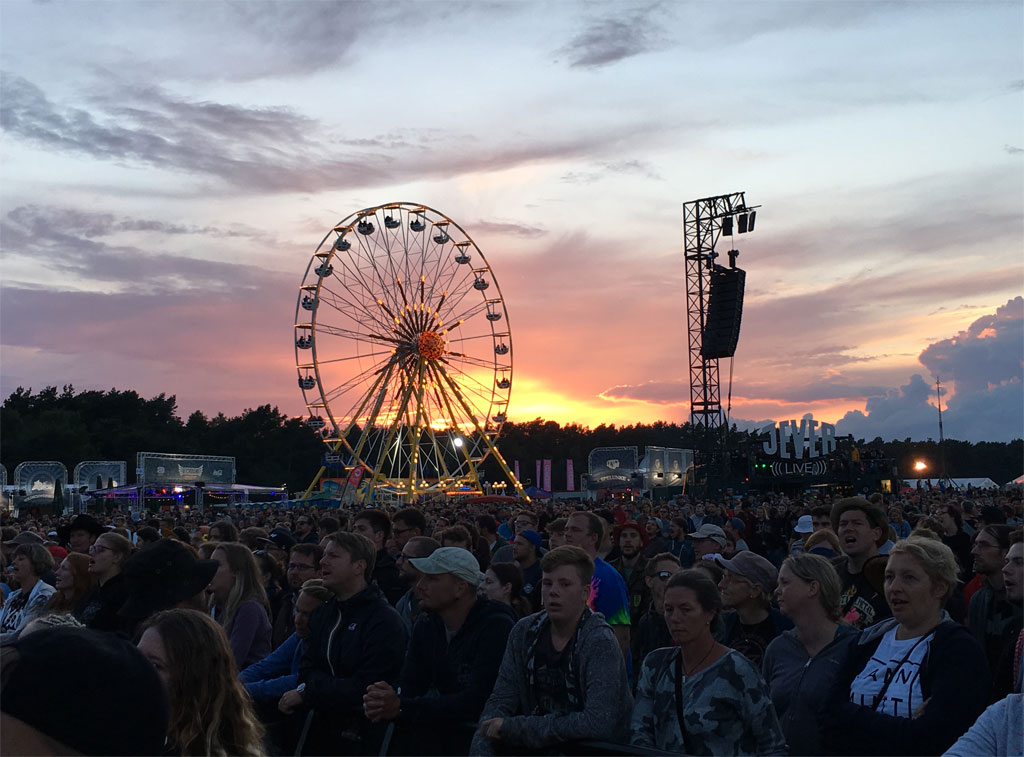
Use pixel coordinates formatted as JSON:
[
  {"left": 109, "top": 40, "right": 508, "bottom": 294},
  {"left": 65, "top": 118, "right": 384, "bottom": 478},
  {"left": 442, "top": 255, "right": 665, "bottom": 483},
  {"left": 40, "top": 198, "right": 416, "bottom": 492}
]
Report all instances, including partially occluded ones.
[{"left": 120, "top": 539, "right": 219, "bottom": 620}]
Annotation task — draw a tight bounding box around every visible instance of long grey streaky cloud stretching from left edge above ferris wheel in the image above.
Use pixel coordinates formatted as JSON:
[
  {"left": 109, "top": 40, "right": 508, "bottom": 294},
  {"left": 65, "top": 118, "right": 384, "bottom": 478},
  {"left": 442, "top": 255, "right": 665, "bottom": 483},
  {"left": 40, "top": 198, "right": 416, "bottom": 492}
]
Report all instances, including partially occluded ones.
[{"left": 0, "top": 74, "right": 668, "bottom": 193}]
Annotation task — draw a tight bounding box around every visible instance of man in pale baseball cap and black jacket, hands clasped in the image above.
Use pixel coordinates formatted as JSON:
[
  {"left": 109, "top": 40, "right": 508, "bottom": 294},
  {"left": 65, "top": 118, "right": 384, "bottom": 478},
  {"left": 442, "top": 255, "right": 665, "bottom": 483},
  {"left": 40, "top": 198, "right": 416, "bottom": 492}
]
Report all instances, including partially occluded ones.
[{"left": 364, "top": 547, "right": 516, "bottom": 754}]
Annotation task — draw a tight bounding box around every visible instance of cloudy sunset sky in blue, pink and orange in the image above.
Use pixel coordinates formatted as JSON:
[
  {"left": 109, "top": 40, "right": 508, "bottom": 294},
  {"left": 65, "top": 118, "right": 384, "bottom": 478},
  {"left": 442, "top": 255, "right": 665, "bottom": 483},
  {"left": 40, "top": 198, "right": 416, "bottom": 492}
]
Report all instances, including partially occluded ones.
[{"left": 0, "top": 0, "right": 1024, "bottom": 440}]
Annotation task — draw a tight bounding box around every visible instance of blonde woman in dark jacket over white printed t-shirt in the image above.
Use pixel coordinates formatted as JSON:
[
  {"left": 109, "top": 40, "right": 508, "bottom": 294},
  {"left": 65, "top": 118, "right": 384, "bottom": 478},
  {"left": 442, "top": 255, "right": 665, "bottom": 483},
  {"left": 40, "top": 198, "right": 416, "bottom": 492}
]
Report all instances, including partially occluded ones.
[{"left": 822, "top": 536, "right": 991, "bottom": 755}]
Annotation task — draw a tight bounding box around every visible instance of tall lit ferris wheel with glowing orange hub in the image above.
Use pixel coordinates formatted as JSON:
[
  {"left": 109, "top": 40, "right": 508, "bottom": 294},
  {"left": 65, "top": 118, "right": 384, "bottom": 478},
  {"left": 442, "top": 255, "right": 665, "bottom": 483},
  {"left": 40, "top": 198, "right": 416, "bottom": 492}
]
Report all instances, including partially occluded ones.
[{"left": 295, "top": 203, "right": 525, "bottom": 502}]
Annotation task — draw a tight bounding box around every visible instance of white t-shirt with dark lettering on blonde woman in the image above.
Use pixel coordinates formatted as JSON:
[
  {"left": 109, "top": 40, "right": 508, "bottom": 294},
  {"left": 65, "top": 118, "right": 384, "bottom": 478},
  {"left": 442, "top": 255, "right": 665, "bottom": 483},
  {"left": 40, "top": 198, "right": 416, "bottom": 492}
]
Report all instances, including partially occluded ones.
[{"left": 850, "top": 627, "right": 935, "bottom": 718}]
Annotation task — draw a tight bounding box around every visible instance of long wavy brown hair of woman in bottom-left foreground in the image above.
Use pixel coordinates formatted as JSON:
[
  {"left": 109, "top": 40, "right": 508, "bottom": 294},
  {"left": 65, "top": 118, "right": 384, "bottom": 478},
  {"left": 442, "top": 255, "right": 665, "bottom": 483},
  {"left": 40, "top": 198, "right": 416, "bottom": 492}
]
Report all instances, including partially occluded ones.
[{"left": 143, "top": 610, "right": 263, "bottom": 755}]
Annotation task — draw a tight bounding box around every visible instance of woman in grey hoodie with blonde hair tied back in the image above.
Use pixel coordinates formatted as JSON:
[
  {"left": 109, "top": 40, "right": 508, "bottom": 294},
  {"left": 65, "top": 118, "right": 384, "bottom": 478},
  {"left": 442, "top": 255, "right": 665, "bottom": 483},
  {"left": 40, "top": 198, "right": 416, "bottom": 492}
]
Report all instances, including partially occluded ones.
[{"left": 762, "top": 553, "right": 856, "bottom": 755}]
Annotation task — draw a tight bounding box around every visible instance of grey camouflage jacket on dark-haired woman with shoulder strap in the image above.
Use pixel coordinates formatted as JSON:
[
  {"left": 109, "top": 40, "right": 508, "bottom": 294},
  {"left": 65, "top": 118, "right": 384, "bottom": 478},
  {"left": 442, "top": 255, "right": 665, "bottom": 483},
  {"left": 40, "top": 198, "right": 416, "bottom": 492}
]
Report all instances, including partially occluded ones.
[{"left": 631, "top": 647, "right": 786, "bottom": 755}]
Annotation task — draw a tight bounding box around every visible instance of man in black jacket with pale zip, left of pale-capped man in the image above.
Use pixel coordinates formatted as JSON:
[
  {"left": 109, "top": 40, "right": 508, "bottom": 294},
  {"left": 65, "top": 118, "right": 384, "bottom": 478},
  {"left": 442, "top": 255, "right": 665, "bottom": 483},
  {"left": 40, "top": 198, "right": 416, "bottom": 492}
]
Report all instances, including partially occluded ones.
[{"left": 279, "top": 532, "right": 409, "bottom": 754}]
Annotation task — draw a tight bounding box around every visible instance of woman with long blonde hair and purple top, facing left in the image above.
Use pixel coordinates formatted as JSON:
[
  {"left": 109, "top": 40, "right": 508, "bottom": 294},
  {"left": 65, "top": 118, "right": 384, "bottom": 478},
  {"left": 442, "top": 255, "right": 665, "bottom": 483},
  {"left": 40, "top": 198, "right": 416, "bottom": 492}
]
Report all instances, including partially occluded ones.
[{"left": 210, "top": 542, "right": 272, "bottom": 670}]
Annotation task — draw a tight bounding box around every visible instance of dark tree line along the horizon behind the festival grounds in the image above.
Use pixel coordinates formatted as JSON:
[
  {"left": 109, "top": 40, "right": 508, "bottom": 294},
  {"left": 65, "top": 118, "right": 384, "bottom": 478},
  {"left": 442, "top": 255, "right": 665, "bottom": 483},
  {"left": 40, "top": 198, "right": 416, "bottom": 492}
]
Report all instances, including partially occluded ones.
[{"left": 0, "top": 384, "right": 1024, "bottom": 492}]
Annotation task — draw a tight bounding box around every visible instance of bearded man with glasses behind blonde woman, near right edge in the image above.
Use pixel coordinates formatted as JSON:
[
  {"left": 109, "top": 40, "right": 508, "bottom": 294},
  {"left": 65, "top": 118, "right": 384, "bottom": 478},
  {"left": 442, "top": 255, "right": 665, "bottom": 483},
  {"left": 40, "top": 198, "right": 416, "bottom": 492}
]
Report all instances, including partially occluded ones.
[{"left": 967, "top": 525, "right": 1024, "bottom": 702}]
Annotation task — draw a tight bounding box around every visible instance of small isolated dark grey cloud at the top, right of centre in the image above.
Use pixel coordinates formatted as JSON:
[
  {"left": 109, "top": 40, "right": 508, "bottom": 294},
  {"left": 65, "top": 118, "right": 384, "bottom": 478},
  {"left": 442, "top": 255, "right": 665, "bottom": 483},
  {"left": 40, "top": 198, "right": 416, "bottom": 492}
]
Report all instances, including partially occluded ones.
[{"left": 558, "top": 5, "right": 663, "bottom": 69}]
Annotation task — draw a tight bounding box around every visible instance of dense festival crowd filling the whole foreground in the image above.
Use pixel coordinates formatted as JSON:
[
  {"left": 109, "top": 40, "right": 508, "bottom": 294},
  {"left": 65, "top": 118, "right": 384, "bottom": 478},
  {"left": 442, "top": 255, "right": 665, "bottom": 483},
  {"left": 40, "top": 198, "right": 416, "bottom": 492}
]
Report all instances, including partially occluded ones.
[{"left": 0, "top": 490, "right": 1024, "bottom": 755}]
